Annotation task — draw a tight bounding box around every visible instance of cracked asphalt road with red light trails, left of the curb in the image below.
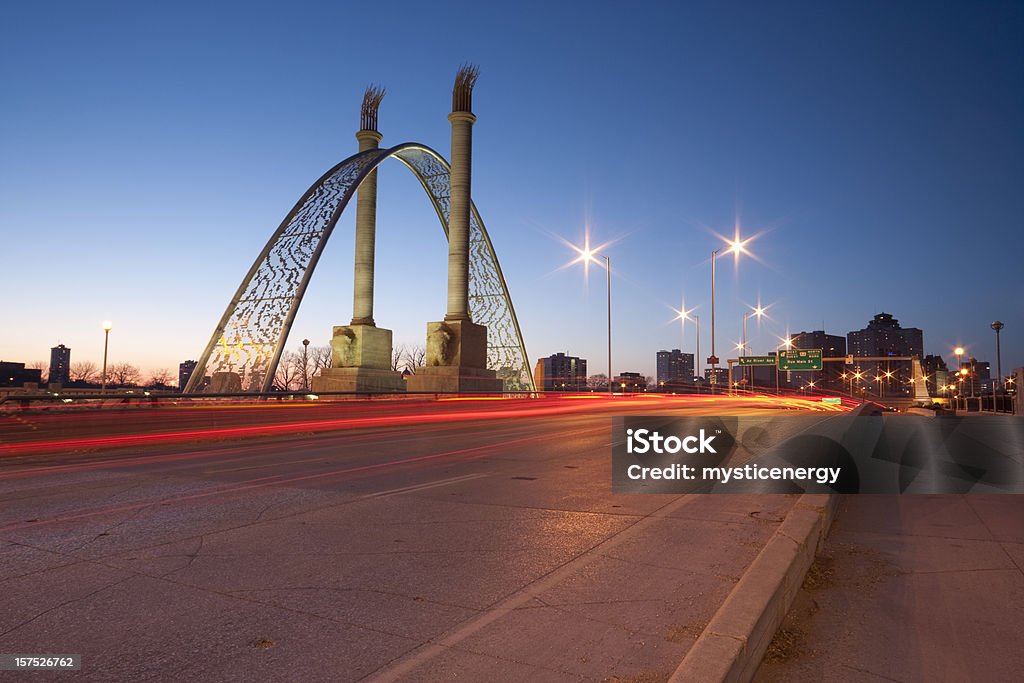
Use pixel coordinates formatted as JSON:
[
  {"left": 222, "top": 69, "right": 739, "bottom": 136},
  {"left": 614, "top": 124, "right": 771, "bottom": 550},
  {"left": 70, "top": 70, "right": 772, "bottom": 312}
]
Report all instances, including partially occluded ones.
[{"left": 0, "top": 396, "right": 836, "bottom": 681}]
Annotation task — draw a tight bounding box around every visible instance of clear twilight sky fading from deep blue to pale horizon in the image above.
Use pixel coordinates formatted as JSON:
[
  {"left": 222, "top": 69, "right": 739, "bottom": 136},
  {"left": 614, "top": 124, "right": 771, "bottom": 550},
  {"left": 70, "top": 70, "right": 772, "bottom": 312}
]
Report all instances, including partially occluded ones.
[{"left": 0, "top": 0, "right": 1024, "bottom": 374}]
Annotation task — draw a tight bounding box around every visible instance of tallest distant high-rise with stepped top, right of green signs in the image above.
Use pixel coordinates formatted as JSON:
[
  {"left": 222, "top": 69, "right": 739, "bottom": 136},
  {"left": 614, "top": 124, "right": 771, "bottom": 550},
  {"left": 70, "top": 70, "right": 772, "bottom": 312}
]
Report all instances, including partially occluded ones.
[{"left": 846, "top": 313, "right": 925, "bottom": 395}]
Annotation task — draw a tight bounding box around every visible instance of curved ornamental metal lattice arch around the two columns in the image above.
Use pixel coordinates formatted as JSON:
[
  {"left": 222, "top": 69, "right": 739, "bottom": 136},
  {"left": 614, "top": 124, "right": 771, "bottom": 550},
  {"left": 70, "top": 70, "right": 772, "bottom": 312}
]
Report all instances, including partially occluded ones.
[{"left": 183, "top": 142, "right": 536, "bottom": 393}]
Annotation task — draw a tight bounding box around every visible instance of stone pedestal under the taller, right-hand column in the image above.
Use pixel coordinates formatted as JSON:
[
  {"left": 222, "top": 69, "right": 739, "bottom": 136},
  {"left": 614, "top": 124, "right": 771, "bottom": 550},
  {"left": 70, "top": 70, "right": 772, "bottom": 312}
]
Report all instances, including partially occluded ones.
[{"left": 406, "top": 321, "right": 505, "bottom": 393}]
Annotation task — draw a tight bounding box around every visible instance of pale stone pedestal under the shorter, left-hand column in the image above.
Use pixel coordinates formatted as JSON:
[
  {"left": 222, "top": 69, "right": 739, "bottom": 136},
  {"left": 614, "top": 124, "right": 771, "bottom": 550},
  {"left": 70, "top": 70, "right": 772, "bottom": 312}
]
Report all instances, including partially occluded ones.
[{"left": 312, "top": 325, "right": 406, "bottom": 393}]
